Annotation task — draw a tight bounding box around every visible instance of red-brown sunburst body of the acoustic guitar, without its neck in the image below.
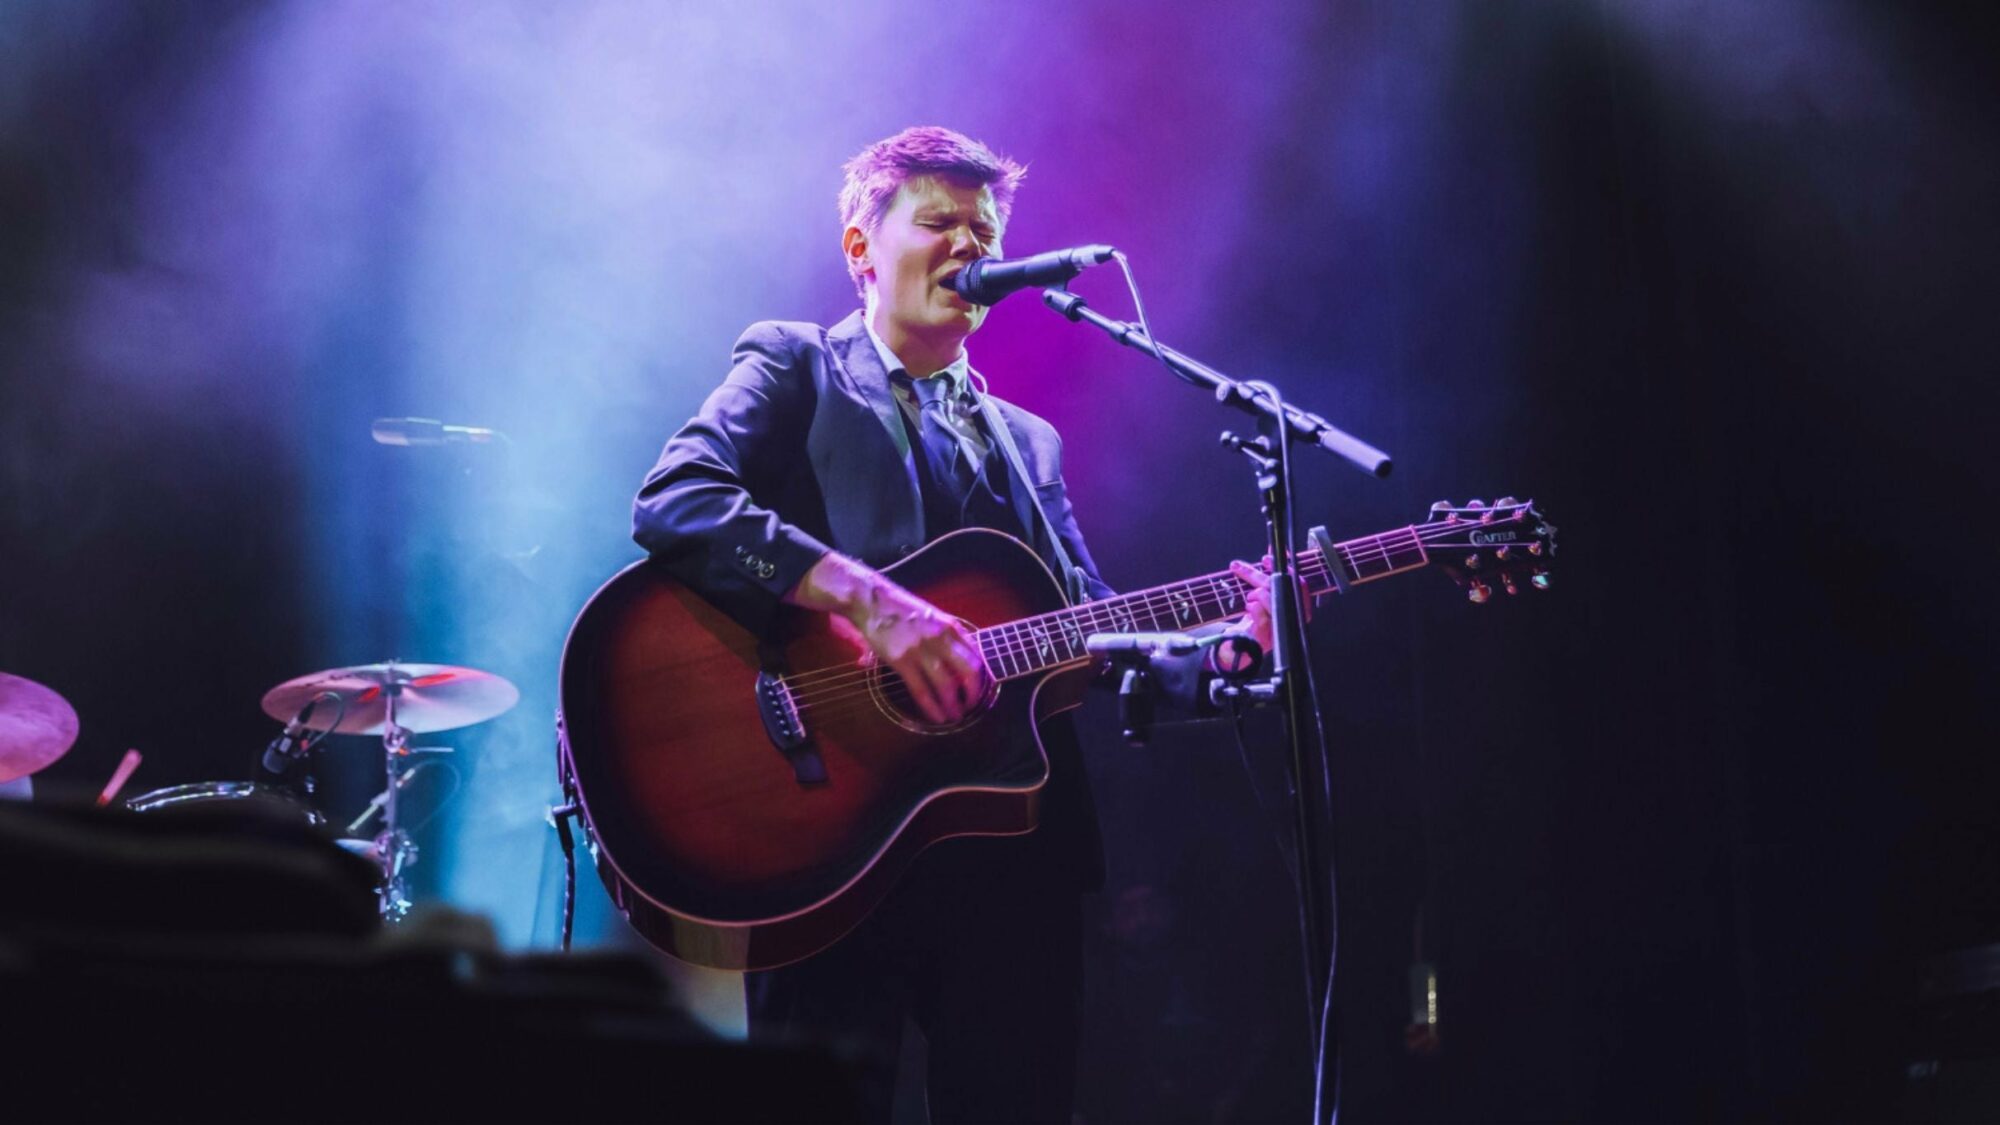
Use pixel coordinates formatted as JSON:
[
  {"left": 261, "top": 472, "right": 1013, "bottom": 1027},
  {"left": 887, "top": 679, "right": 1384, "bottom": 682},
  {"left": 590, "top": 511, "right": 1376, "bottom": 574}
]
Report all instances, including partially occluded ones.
[{"left": 560, "top": 530, "right": 1092, "bottom": 969}]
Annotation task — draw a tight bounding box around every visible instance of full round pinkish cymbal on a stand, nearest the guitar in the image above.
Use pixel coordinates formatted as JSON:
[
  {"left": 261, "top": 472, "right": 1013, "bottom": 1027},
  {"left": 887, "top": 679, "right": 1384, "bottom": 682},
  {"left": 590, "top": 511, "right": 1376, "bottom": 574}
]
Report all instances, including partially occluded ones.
[{"left": 264, "top": 665, "right": 520, "bottom": 735}]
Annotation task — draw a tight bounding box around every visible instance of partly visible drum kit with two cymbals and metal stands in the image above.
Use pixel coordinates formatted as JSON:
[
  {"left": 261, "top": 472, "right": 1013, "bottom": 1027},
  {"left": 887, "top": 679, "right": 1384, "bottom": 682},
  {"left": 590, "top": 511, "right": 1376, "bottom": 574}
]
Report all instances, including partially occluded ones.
[{"left": 0, "top": 661, "right": 520, "bottom": 923}]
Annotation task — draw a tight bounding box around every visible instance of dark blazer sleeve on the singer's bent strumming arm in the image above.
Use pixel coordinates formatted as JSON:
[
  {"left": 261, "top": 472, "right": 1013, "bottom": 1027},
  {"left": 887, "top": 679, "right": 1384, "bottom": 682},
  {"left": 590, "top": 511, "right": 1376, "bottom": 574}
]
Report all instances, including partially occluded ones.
[{"left": 632, "top": 322, "right": 828, "bottom": 635}]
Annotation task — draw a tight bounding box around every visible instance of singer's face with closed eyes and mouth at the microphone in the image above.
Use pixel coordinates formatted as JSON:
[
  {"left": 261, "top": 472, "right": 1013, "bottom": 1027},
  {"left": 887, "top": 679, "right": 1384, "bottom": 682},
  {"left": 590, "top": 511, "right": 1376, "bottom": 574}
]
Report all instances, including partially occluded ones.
[{"left": 844, "top": 176, "right": 1000, "bottom": 346}]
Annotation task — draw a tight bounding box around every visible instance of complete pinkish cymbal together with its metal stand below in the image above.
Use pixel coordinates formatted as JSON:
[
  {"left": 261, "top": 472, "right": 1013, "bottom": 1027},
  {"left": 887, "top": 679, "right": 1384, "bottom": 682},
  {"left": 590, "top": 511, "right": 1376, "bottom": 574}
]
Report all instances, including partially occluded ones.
[{"left": 264, "top": 661, "right": 520, "bottom": 923}]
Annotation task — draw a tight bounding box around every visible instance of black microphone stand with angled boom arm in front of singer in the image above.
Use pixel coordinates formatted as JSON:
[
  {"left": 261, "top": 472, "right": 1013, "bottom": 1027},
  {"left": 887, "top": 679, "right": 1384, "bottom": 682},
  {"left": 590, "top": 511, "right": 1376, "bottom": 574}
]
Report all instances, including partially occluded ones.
[{"left": 1042, "top": 288, "right": 1390, "bottom": 1117}]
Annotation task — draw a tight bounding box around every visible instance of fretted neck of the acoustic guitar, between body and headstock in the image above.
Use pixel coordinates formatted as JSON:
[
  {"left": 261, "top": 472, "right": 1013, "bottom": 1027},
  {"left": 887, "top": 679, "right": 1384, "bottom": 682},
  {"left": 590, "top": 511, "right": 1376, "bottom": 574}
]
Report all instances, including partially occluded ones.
[{"left": 978, "top": 526, "right": 1430, "bottom": 681}]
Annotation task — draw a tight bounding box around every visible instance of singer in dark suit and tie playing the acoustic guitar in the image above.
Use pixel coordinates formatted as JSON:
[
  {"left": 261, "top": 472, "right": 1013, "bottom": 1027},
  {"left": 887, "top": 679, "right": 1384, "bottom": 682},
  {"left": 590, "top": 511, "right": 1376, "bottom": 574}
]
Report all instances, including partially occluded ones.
[{"left": 634, "top": 126, "right": 1270, "bottom": 1123}]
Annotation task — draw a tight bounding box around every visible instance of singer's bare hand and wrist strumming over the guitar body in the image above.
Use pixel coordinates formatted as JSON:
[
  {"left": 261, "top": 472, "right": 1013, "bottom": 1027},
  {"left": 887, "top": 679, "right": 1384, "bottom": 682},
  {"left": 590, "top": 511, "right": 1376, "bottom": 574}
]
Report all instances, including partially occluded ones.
[{"left": 786, "top": 554, "right": 988, "bottom": 725}]
